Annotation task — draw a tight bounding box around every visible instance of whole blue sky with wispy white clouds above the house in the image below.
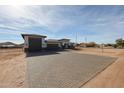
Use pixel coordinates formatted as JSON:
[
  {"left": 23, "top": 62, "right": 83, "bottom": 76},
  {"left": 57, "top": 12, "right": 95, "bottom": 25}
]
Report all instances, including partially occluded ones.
[{"left": 0, "top": 5, "right": 124, "bottom": 43}]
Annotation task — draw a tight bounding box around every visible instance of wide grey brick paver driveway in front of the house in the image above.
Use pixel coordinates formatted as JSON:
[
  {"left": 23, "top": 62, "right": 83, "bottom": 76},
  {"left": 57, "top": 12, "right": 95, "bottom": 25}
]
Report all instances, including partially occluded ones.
[{"left": 27, "top": 51, "right": 116, "bottom": 88}]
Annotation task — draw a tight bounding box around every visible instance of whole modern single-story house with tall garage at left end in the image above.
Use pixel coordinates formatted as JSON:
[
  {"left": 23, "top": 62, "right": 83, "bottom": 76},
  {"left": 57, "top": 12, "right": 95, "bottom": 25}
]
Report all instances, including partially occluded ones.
[{"left": 22, "top": 34, "right": 74, "bottom": 51}]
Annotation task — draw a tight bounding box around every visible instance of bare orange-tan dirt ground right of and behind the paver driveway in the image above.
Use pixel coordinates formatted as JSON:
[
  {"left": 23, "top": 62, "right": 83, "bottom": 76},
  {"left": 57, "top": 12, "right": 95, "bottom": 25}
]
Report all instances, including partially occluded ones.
[{"left": 75, "top": 48, "right": 124, "bottom": 88}]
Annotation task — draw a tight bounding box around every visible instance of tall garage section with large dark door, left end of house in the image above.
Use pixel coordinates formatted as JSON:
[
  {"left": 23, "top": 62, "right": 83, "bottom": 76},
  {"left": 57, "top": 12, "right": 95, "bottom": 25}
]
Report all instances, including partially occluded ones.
[{"left": 22, "top": 34, "right": 47, "bottom": 51}]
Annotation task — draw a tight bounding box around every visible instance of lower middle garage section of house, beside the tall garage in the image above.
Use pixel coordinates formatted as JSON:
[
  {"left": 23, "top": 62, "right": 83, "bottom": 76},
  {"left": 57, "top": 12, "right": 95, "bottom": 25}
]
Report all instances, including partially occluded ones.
[{"left": 46, "top": 39, "right": 62, "bottom": 50}]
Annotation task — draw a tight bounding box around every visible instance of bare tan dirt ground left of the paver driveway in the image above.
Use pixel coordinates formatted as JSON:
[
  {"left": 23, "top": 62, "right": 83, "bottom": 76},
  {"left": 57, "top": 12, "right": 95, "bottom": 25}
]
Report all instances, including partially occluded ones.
[{"left": 0, "top": 49, "right": 26, "bottom": 88}]
